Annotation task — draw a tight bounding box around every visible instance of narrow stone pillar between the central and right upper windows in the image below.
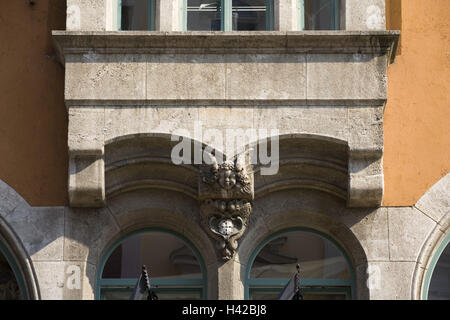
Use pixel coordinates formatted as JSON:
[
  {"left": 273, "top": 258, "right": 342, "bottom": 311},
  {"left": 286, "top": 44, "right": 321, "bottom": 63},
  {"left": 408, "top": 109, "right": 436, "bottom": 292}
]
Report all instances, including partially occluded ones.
[{"left": 273, "top": 0, "right": 300, "bottom": 31}]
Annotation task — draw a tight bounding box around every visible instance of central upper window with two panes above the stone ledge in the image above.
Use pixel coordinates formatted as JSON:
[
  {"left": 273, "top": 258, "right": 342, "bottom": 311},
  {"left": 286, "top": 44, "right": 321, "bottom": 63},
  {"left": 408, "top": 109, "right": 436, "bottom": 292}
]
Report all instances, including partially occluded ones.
[{"left": 183, "top": 0, "right": 273, "bottom": 31}]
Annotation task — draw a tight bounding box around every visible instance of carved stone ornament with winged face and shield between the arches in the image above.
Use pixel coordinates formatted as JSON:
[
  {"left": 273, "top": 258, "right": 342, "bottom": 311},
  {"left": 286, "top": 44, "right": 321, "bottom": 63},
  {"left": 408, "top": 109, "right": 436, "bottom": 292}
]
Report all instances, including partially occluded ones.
[{"left": 199, "top": 155, "right": 253, "bottom": 261}]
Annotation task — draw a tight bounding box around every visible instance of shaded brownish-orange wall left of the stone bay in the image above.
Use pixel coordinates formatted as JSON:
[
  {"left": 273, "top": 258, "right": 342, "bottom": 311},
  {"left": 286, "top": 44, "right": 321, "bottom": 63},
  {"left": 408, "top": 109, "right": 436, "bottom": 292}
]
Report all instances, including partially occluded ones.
[{"left": 0, "top": 0, "right": 68, "bottom": 206}]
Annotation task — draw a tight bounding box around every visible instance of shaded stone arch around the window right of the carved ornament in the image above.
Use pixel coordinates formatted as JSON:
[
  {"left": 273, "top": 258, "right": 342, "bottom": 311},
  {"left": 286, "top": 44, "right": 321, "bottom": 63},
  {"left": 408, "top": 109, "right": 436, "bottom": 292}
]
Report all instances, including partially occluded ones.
[{"left": 237, "top": 189, "right": 369, "bottom": 299}]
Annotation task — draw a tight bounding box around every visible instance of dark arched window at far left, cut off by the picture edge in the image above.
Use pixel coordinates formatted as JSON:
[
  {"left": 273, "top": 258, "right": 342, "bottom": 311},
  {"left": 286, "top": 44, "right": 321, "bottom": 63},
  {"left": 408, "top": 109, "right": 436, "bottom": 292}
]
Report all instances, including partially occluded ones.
[{"left": 0, "top": 242, "right": 26, "bottom": 300}]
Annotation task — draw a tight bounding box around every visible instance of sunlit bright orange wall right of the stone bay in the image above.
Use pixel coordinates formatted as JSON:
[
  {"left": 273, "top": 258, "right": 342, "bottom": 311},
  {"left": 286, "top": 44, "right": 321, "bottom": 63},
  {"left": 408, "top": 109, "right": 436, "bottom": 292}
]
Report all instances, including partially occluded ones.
[{"left": 383, "top": 0, "right": 450, "bottom": 206}]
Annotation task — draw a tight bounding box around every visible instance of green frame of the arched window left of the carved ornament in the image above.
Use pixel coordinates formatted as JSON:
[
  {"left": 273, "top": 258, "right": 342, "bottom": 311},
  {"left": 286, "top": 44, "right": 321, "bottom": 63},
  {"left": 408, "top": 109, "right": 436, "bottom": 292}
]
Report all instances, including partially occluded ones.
[{"left": 95, "top": 228, "right": 208, "bottom": 300}]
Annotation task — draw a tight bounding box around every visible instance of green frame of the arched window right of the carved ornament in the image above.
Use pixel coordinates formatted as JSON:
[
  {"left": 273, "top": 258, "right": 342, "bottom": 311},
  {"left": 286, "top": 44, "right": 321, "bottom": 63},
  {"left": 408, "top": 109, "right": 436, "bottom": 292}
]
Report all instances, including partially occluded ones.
[{"left": 244, "top": 227, "right": 356, "bottom": 300}]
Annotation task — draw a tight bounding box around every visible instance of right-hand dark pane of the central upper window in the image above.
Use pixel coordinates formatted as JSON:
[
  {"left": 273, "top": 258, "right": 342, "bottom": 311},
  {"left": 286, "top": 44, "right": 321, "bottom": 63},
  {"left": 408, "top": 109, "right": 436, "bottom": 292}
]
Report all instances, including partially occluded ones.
[{"left": 233, "top": 0, "right": 268, "bottom": 31}]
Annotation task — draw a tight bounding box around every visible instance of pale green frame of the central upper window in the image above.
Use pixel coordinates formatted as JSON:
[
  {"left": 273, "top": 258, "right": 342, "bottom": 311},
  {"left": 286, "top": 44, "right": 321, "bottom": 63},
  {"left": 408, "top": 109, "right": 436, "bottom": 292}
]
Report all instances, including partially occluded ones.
[{"left": 180, "top": 0, "right": 274, "bottom": 32}]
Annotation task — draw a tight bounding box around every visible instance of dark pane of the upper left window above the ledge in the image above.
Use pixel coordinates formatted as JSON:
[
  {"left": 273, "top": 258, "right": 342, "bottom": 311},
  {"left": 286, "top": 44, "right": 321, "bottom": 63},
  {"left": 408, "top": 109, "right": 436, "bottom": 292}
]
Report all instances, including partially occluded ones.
[{"left": 121, "top": 0, "right": 150, "bottom": 30}]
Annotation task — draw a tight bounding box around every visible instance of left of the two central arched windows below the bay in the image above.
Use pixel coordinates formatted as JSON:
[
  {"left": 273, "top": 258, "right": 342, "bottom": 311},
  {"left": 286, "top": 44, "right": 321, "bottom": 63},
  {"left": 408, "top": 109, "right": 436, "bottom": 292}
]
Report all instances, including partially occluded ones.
[{"left": 96, "top": 229, "right": 206, "bottom": 300}]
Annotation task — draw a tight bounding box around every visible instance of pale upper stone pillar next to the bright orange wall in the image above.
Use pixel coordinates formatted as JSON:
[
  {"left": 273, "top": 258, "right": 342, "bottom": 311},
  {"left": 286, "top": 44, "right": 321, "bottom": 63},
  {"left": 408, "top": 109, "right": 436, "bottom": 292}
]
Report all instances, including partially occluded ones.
[{"left": 344, "top": 0, "right": 386, "bottom": 31}]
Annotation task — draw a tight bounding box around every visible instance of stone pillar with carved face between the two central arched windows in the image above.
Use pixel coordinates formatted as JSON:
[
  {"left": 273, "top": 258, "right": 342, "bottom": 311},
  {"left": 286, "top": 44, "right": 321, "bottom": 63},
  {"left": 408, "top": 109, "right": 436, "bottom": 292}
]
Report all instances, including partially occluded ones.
[{"left": 199, "top": 155, "right": 254, "bottom": 300}]
